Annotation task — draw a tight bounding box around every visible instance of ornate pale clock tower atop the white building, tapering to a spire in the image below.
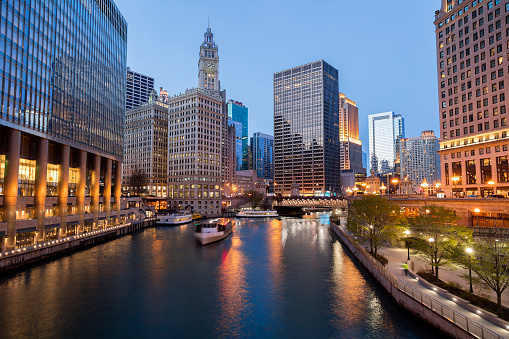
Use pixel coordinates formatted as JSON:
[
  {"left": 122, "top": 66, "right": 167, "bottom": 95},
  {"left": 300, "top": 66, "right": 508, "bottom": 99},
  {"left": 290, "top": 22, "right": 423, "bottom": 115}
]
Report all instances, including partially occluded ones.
[{"left": 198, "top": 27, "right": 221, "bottom": 93}]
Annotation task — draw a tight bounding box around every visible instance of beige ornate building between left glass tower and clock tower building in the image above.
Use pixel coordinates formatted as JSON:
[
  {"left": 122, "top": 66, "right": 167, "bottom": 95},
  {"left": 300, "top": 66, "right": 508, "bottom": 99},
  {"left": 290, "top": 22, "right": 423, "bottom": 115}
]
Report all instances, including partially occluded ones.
[{"left": 122, "top": 90, "right": 168, "bottom": 198}]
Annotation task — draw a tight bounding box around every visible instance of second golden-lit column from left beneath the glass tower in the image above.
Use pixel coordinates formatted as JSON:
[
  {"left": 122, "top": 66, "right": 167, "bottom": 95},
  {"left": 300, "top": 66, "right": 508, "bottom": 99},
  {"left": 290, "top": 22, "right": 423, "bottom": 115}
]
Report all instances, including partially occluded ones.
[{"left": 34, "top": 138, "right": 48, "bottom": 244}]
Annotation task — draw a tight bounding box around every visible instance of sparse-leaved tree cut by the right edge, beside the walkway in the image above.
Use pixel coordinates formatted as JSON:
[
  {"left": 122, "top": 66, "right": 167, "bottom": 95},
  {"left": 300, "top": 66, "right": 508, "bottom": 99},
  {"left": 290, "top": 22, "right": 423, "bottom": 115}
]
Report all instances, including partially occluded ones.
[{"left": 458, "top": 237, "right": 509, "bottom": 315}]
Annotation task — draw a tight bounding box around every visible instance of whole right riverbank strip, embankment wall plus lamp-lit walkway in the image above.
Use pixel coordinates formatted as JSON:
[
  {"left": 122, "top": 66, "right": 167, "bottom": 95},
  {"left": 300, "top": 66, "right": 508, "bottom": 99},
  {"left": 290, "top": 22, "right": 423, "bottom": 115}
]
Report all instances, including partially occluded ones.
[{"left": 331, "top": 222, "right": 509, "bottom": 338}]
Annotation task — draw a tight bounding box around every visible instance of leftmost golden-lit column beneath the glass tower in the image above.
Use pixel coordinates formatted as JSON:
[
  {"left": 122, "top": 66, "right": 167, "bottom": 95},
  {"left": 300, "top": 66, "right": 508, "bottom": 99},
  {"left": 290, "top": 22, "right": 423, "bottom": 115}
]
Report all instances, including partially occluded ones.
[{"left": 3, "top": 128, "right": 21, "bottom": 251}]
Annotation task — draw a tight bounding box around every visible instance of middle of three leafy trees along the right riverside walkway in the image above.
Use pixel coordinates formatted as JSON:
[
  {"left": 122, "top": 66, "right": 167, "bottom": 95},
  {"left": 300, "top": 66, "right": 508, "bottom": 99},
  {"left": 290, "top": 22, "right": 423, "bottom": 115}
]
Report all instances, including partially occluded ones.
[{"left": 410, "top": 205, "right": 472, "bottom": 282}]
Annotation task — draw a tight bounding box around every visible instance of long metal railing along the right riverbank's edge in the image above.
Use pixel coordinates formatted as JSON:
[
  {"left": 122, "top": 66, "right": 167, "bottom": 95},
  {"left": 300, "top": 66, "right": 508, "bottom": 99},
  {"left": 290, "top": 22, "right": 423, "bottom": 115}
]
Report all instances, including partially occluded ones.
[{"left": 331, "top": 223, "right": 504, "bottom": 339}]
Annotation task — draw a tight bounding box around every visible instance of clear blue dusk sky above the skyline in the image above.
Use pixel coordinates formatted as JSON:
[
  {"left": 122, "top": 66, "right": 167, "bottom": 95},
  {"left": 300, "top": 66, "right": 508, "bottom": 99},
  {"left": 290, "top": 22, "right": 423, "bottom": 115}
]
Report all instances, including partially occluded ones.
[{"left": 115, "top": 0, "right": 440, "bottom": 152}]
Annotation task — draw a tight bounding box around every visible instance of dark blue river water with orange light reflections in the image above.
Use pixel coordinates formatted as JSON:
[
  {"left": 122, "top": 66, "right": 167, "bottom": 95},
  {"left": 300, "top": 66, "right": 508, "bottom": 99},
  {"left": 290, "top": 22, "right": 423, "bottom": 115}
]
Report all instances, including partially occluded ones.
[{"left": 0, "top": 213, "right": 440, "bottom": 338}]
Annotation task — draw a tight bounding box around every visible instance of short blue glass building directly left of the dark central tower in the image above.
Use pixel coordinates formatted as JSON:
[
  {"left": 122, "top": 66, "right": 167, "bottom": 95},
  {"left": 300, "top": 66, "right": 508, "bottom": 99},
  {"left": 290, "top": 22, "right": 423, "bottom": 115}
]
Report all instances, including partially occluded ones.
[{"left": 250, "top": 132, "right": 274, "bottom": 180}]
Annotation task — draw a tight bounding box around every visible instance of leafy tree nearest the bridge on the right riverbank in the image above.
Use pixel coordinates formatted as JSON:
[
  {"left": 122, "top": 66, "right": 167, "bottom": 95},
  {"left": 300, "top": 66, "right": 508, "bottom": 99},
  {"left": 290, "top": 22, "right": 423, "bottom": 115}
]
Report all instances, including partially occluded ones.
[{"left": 347, "top": 195, "right": 400, "bottom": 258}]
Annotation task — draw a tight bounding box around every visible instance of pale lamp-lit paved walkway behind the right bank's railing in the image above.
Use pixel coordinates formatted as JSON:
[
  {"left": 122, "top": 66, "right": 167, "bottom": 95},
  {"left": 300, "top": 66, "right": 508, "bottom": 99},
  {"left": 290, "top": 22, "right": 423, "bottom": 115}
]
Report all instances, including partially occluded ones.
[{"left": 341, "top": 222, "right": 509, "bottom": 338}]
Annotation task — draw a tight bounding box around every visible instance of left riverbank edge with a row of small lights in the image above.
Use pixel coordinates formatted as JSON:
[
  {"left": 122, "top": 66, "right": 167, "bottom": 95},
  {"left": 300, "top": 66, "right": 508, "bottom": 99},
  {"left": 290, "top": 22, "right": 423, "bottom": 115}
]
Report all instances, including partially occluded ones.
[{"left": 0, "top": 217, "right": 156, "bottom": 272}]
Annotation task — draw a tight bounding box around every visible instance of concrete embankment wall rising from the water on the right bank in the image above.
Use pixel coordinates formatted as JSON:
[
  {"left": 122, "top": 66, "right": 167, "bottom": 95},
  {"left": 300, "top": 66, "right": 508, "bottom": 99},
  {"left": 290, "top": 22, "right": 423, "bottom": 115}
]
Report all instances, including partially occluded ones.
[{"left": 331, "top": 222, "right": 502, "bottom": 339}]
